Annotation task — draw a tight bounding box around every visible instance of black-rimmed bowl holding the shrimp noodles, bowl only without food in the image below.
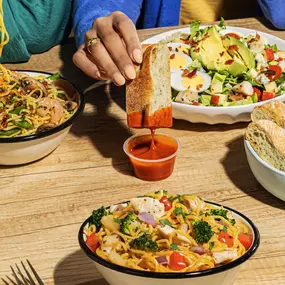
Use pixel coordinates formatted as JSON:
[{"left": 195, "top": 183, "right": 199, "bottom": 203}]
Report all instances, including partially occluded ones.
[{"left": 0, "top": 70, "right": 84, "bottom": 165}]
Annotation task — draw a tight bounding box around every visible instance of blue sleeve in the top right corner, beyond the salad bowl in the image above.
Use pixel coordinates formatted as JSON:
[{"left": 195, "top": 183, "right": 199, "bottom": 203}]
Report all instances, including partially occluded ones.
[{"left": 258, "top": 0, "right": 285, "bottom": 30}]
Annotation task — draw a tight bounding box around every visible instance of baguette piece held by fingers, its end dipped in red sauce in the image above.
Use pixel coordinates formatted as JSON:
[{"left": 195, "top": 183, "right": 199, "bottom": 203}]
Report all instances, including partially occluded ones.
[{"left": 126, "top": 42, "right": 172, "bottom": 128}]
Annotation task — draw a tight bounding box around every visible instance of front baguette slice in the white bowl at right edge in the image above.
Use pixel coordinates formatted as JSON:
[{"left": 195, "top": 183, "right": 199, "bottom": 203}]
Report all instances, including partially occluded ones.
[{"left": 245, "top": 120, "right": 285, "bottom": 171}]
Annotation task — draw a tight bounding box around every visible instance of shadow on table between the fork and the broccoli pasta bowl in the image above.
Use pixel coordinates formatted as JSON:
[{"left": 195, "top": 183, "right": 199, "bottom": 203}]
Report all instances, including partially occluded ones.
[{"left": 53, "top": 250, "right": 108, "bottom": 285}]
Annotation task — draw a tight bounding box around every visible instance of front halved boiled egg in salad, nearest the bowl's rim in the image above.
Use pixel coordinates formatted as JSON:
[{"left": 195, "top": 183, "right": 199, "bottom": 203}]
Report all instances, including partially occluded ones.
[{"left": 171, "top": 71, "right": 211, "bottom": 92}]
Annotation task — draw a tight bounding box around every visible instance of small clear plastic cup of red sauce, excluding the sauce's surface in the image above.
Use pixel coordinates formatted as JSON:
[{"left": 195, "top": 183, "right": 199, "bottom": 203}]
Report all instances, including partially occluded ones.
[{"left": 123, "top": 132, "right": 180, "bottom": 181}]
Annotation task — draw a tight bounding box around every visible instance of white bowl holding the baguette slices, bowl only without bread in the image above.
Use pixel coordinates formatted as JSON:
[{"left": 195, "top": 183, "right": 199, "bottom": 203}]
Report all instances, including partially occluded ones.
[{"left": 244, "top": 139, "right": 285, "bottom": 201}]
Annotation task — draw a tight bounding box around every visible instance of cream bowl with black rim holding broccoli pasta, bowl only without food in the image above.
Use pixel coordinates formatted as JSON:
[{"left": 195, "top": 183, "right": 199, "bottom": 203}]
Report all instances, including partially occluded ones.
[{"left": 78, "top": 202, "right": 260, "bottom": 285}]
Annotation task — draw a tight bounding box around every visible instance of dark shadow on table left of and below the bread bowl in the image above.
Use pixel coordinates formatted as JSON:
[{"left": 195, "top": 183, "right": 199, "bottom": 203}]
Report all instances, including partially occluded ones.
[{"left": 221, "top": 136, "right": 285, "bottom": 209}]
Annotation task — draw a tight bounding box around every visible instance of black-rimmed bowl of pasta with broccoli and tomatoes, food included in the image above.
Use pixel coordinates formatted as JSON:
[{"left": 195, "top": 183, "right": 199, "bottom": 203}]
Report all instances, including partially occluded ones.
[{"left": 79, "top": 190, "right": 260, "bottom": 285}]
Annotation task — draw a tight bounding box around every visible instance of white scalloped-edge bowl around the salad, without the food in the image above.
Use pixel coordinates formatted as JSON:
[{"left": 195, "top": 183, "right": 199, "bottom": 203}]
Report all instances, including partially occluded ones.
[{"left": 142, "top": 26, "right": 285, "bottom": 125}]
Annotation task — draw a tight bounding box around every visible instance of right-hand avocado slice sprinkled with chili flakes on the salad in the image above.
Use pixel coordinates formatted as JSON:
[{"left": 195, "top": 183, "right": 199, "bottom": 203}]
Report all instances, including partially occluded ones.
[{"left": 222, "top": 36, "right": 255, "bottom": 69}]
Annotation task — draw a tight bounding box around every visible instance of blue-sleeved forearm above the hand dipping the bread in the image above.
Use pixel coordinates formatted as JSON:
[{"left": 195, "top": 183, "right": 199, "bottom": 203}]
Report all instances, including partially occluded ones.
[{"left": 73, "top": 0, "right": 142, "bottom": 46}]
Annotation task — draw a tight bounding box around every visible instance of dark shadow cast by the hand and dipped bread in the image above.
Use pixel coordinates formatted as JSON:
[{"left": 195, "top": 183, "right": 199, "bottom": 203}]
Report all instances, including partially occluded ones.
[{"left": 60, "top": 39, "right": 132, "bottom": 175}]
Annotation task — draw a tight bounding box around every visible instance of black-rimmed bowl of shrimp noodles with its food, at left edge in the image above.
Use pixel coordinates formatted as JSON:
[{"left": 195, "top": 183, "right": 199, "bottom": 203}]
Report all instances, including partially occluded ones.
[{"left": 0, "top": 65, "right": 84, "bottom": 165}]
